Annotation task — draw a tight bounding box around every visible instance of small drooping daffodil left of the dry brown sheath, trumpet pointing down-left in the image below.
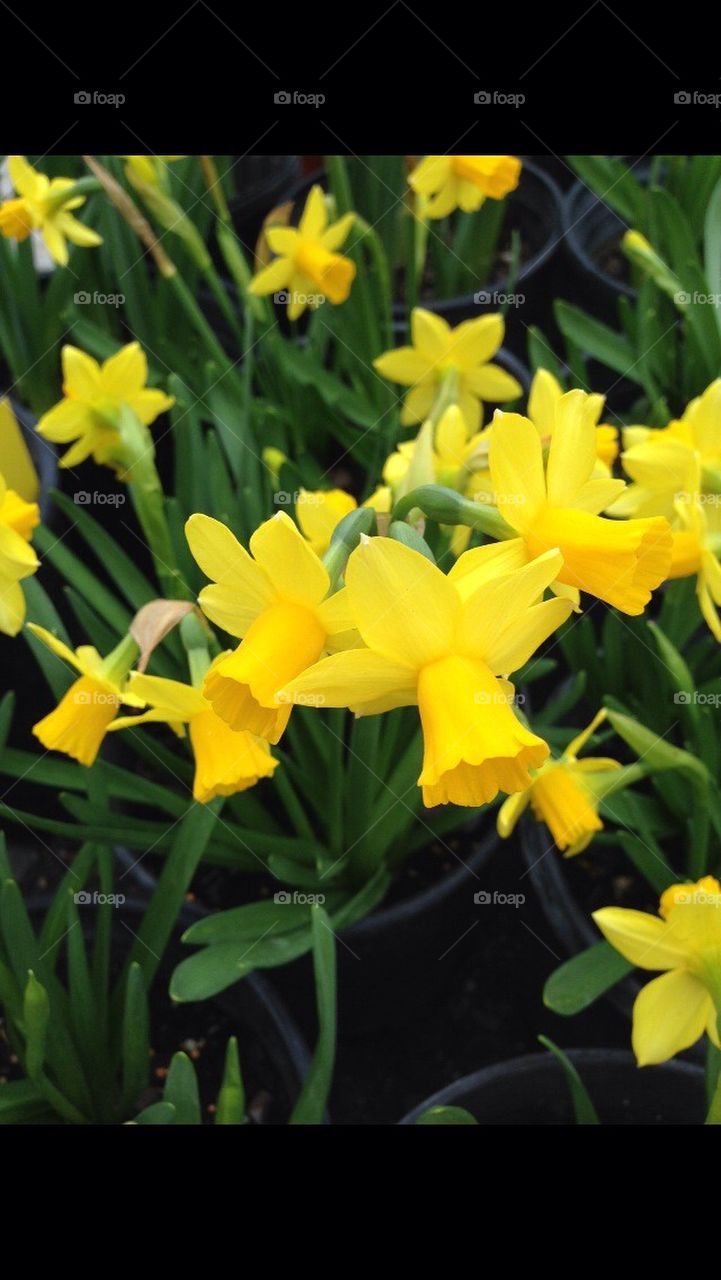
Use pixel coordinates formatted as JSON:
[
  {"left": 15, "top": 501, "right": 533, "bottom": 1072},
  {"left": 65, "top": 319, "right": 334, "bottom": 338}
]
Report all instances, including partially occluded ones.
[{"left": 28, "top": 622, "right": 145, "bottom": 767}]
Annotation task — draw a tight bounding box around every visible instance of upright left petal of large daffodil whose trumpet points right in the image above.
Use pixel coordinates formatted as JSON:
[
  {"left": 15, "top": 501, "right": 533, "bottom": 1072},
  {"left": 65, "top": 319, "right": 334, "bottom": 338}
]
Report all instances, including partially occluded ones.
[{"left": 488, "top": 410, "right": 548, "bottom": 529}]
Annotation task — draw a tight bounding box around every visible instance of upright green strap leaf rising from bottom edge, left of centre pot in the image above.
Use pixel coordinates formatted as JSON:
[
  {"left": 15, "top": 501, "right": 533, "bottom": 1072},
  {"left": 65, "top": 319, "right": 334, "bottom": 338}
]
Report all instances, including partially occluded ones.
[{"left": 289, "top": 906, "right": 336, "bottom": 1124}]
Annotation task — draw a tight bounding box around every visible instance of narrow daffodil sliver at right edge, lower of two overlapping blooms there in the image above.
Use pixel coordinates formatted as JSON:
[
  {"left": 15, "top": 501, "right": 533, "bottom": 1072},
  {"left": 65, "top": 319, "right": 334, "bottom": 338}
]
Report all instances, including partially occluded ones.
[{"left": 668, "top": 476, "right": 721, "bottom": 643}]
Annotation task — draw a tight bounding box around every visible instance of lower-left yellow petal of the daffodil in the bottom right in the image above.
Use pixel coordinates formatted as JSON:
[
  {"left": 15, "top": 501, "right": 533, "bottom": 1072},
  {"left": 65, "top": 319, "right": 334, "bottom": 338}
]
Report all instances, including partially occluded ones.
[{"left": 633, "top": 970, "right": 713, "bottom": 1066}]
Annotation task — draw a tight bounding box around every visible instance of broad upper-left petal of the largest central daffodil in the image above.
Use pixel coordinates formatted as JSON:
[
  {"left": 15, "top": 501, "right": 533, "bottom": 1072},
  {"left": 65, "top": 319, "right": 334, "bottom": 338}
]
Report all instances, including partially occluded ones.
[{"left": 346, "top": 538, "right": 461, "bottom": 668}]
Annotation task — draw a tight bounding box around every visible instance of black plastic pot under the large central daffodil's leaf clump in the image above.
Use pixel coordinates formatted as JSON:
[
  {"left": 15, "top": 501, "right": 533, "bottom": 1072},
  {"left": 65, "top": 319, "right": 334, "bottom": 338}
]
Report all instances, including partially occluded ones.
[{"left": 271, "top": 826, "right": 498, "bottom": 1039}]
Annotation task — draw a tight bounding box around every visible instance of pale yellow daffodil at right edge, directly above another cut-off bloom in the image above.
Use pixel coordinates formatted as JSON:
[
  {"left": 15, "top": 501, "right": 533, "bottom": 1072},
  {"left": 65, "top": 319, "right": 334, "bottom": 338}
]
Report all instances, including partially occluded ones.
[{"left": 610, "top": 378, "right": 721, "bottom": 520}]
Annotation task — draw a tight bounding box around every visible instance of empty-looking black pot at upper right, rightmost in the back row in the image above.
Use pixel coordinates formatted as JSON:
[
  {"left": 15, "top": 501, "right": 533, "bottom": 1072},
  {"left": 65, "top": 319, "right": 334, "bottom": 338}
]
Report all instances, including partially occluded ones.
[{"left": 561, "top": 182, "right": 636, "bottom": 328}]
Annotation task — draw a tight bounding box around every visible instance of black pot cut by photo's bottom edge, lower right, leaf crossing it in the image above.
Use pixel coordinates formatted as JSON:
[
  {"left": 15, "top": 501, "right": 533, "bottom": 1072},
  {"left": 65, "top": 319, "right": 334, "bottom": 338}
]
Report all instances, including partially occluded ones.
[{"left": 401, "top": 1048, "right": 706, "bottom": 1125}]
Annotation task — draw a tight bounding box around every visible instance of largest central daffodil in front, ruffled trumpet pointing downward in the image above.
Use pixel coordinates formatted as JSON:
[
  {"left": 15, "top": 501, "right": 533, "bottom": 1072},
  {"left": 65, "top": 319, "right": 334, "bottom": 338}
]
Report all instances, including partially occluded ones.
[{"left": 283, "top": 538, "right": 570, "bottom": 805}]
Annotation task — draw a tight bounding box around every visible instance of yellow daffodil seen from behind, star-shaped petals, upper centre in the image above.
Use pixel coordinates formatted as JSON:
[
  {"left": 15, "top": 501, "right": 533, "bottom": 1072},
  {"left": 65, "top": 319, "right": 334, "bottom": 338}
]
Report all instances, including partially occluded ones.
[{"left": 373, "top": 307, "right": 523, "bottom": 434}]
